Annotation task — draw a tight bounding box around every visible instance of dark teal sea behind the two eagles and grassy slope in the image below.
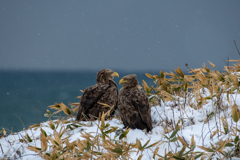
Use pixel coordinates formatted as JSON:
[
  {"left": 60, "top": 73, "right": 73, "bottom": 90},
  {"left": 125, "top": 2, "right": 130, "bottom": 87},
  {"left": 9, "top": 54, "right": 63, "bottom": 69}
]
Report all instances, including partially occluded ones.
[{"left": 0, "top": 71, "right": 159, "bottom": 133}]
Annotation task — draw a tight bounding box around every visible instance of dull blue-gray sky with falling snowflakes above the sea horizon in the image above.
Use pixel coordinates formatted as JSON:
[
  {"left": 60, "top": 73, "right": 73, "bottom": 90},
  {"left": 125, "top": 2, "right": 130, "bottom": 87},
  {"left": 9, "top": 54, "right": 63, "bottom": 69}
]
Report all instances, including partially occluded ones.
[{"left": 0, "top": 0, "right": 240, "bottom": 72}]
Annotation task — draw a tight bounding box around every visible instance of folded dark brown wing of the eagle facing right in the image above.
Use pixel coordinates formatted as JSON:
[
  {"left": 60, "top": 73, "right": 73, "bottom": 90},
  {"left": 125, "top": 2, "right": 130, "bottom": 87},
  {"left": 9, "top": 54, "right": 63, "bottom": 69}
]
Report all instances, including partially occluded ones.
[{"left": 77, "top": 84, "right": 110, "bottom": 120}]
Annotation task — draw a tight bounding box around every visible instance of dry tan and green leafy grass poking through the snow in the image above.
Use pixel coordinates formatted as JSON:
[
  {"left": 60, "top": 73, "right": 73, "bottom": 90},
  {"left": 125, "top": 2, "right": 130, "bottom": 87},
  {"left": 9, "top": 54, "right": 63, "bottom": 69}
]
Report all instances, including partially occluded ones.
[{"left": 0, "top": 60, "right": 240, "bottom": 160}]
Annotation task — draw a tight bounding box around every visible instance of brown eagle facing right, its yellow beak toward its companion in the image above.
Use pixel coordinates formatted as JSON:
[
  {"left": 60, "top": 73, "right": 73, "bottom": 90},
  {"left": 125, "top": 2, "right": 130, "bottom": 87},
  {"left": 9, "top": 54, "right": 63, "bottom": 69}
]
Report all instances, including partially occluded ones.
[{"left": 76, "top": 69, "right": 119, "bottom": 121}]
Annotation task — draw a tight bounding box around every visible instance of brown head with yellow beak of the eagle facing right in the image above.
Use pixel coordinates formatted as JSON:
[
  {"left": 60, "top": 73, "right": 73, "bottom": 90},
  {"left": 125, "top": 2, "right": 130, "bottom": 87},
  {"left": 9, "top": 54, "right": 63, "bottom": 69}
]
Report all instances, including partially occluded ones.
[{"left": 97, "top": 69, "right": 119, "bottom": 83}]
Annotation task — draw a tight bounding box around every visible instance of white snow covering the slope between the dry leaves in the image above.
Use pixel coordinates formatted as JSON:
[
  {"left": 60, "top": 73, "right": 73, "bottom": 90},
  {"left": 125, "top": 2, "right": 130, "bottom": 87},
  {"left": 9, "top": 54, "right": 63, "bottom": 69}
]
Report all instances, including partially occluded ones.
[{"left": 0, "top": 91, "right": 240, "bottom": 160}]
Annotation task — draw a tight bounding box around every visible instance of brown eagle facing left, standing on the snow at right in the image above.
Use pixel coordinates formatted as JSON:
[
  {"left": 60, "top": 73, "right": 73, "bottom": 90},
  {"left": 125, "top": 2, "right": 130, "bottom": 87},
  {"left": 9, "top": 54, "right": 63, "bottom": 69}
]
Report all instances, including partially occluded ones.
[{"left": 118, "top": 74, "right": 152, "bottom": 132}]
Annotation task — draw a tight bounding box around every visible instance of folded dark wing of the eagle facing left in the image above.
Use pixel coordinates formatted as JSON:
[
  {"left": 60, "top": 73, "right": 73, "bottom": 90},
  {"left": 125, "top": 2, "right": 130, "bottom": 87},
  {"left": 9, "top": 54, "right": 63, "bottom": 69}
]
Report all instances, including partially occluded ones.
[{"left": 132, "top": 93, "right": 152, "bottom": 131}]
